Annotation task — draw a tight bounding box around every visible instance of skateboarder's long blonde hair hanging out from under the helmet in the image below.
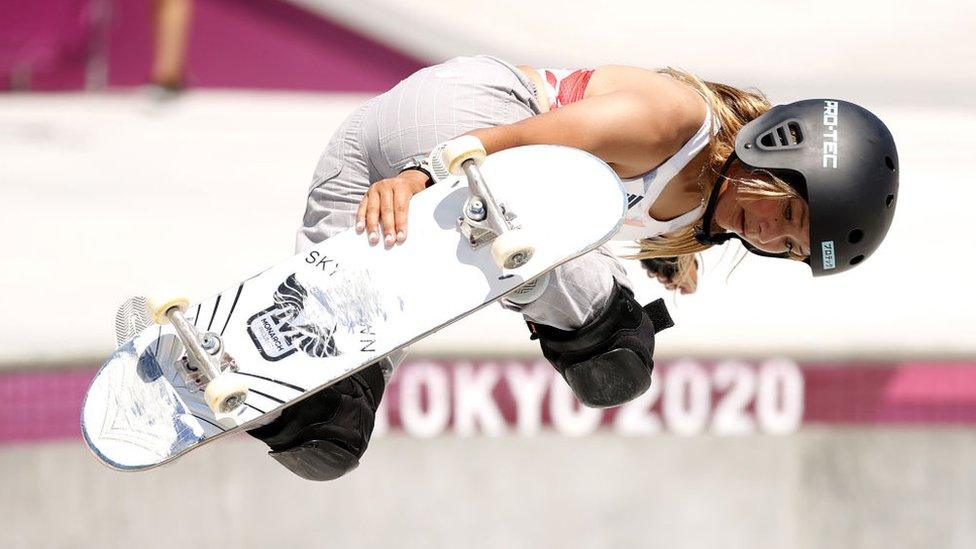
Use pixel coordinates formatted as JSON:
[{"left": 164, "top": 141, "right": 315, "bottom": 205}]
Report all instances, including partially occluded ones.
[{"left": 626, "top": 67, "right": 802, "bottom": 285}]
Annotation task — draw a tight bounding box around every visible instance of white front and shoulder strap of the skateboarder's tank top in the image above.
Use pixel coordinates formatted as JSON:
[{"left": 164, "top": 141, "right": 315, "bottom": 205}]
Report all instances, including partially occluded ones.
[{"left": 613, "top": 106, "right": 718, "bottom": 240}]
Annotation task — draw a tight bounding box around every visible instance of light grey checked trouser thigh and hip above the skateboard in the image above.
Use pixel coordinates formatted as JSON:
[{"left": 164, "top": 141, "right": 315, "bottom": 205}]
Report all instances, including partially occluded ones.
[{"left": 296, "top": 56, "right": 539, "bottom": 251}]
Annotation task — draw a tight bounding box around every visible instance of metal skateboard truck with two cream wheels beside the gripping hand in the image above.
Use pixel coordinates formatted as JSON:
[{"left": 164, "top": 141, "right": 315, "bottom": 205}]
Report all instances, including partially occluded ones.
[{"left": 441, "top": 135, "right": 535, "bottom": 269}]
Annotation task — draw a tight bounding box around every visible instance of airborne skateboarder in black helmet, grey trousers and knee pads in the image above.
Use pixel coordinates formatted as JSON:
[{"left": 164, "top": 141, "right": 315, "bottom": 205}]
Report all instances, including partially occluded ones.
[{"left": 250, "top": 56, "right": 897, "bottom": 480}]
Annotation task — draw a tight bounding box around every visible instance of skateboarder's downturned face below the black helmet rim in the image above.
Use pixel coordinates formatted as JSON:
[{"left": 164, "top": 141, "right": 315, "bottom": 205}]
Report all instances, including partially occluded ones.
[{"left": 714, "top": 174, "right": 810, "bottom": 256}]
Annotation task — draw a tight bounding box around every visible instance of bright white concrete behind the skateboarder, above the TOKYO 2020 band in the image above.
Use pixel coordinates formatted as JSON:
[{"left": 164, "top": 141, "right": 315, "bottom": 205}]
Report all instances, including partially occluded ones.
[{"left": 0, "top": 92, "right": 976, "bottom": 363}]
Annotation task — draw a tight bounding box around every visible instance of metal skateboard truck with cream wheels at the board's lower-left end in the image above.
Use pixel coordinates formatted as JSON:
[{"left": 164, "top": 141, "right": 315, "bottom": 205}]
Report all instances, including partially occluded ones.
[{"left": 147, "top": 298, "right": 248, "bottom": 420}]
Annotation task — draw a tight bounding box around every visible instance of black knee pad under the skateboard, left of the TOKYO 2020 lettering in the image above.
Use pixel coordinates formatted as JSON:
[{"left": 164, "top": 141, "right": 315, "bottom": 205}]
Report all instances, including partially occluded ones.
[{"left": 248, "top": 363, "right": 385, "bottom": 480}]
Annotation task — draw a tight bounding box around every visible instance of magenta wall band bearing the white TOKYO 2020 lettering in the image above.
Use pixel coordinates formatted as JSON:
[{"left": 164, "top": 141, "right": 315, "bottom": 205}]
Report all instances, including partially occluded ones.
[{"left": 7, "top": 359, "right": 976, "bottom": 444}]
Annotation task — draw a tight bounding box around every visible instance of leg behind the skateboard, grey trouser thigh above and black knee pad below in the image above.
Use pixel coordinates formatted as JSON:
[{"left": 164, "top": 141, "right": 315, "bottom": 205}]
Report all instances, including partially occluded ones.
[{"left": 250, "top": 57, "right": 538, "bottom": 480}]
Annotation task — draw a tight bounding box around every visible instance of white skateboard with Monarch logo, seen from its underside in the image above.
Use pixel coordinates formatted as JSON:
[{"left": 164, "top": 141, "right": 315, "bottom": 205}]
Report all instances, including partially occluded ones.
[{"left": 81, "top": 138, "right": 627, "bottom": 471}]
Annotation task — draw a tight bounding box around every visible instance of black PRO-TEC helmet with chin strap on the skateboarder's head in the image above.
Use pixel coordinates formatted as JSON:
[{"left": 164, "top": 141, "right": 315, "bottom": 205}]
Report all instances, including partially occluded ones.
[{"left": 696, "top": 99, "right": 898, "bottom": 276}]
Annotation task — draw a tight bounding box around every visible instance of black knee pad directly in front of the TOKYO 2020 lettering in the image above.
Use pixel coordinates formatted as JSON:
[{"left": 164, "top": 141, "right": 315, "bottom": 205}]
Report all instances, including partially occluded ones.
[{"left": 529, "top": 282, "right": 674, "bottom": 408}]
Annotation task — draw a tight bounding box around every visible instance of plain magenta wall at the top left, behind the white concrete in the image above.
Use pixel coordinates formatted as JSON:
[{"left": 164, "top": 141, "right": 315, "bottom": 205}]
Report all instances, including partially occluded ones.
[{"left": 0, "top": 0, "right": 423, "bottom": 92}]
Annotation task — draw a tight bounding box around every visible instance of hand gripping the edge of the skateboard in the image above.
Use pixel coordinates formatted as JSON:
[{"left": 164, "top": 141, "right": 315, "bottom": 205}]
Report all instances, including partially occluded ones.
[{"left": 356, "top": 170, "right": 427, "bottom": 248}]
